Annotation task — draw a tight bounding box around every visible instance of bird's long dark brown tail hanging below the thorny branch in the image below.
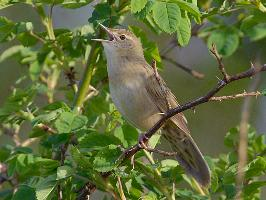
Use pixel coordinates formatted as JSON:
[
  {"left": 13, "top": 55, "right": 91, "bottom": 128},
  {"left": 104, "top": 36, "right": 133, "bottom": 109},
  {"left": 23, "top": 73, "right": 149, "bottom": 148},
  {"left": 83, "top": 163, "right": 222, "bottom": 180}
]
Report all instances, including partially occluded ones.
[{"left": 163, "top": 124, "right": 210, "bottom": 187}]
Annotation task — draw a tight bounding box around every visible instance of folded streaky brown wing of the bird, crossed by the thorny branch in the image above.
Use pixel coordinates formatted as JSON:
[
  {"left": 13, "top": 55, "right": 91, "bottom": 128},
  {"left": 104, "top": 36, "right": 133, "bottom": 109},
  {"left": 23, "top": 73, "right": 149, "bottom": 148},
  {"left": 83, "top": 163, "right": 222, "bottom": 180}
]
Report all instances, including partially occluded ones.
[{"left": 145, "top": 65, "right": 189, "bottom": 134}]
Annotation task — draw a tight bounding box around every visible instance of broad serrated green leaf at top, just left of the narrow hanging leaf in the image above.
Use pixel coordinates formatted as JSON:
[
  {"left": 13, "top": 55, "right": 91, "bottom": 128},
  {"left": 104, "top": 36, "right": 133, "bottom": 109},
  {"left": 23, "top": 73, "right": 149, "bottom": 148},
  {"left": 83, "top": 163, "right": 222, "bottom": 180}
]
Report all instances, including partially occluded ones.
[{"left": 152, "top": 1, "right": 181, "bottom": 33}]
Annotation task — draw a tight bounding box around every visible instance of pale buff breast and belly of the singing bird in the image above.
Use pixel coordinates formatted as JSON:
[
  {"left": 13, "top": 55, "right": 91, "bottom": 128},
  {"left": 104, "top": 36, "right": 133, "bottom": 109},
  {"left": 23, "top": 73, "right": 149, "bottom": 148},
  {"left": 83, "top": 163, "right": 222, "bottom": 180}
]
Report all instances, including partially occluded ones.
[{"left": 108, "top": 58, "right": 161, "bottom": 130}]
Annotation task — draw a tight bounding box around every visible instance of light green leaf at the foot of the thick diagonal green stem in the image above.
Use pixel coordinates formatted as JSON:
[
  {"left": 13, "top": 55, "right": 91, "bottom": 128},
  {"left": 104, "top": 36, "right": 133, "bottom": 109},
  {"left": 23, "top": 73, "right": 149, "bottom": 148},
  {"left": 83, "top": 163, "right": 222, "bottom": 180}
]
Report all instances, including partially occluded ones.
[{"left": 55, "top": 112, "right": 88, "bottom": 133}]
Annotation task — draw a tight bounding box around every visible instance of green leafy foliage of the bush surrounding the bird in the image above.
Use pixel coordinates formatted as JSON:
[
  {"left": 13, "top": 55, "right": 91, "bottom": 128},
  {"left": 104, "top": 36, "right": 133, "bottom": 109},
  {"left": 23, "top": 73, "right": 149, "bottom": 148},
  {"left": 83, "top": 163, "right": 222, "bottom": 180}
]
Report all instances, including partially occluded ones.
[{"left": 0, "top": 0, "right": 266, "bottom": 200}]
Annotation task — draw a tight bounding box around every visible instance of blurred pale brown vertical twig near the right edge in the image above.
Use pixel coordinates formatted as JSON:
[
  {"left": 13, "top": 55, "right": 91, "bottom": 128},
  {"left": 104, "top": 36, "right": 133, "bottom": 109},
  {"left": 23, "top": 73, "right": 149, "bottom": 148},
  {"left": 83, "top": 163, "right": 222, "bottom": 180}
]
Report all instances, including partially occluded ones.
[{"left": 236, "top": 74, "right": 260, "bottom": 200}]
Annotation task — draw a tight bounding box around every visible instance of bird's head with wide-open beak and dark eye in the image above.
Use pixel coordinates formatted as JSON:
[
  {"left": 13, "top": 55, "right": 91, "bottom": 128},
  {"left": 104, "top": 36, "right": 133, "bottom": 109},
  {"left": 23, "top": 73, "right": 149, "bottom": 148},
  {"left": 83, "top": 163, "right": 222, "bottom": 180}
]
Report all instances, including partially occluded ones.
[{"left": 93, "top": 24, "right": 143, "bottom": 55}]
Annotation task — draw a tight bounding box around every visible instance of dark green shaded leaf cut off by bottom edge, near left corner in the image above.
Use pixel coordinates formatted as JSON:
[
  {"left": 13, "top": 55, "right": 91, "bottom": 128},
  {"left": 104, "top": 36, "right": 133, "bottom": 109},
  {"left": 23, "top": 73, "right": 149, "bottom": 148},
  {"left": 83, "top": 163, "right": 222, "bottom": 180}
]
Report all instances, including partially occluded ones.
[{"left": 11, "top": 185, "right": 36, "bottom": 200}]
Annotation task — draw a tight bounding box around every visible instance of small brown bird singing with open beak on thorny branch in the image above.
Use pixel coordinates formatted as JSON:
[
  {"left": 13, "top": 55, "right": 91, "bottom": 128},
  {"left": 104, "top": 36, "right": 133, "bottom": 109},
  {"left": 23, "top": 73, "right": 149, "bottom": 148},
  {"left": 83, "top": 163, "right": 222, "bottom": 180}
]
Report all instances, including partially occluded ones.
[{"left": 94, "top": 24, "right": 210, "bottom": 186}]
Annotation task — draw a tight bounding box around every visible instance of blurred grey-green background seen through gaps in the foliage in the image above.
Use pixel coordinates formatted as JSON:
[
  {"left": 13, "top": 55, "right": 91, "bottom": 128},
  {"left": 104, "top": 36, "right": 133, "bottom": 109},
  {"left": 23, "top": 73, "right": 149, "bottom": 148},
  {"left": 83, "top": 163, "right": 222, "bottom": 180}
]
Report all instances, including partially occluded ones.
[{"left": 0, "top": 5, "right": 266, "bottom": 159}]
